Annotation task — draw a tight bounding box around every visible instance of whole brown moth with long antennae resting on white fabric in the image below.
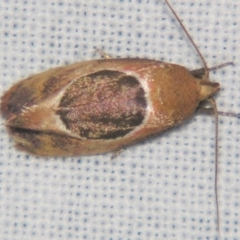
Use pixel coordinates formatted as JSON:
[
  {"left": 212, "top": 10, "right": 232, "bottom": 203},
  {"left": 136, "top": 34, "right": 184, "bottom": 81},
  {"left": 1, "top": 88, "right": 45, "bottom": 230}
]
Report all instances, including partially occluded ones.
[{"left": 1, "top": 0, "right": 237, "bottom": 232}]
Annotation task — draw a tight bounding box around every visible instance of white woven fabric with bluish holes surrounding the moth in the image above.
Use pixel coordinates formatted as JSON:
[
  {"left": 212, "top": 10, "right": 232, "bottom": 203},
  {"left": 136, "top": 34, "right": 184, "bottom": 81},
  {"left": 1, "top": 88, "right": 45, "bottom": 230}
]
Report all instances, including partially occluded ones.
[{"left": 0, "top": 0, "right": 240, "bottom": 240}]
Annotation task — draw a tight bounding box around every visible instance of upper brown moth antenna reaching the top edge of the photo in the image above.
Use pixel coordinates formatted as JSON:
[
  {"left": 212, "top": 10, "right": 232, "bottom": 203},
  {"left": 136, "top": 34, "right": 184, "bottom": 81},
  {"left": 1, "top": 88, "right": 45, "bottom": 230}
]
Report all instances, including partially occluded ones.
[{"left": 165, "top": 0, "right": 209, "bottom": 81}]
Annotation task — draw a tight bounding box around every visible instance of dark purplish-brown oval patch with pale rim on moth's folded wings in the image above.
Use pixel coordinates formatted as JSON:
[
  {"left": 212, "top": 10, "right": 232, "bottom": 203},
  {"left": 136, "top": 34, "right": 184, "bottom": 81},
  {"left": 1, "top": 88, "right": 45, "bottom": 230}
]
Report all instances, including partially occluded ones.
[{"left": 57, "top": 70, "right": 147, "bottom": 139}]
